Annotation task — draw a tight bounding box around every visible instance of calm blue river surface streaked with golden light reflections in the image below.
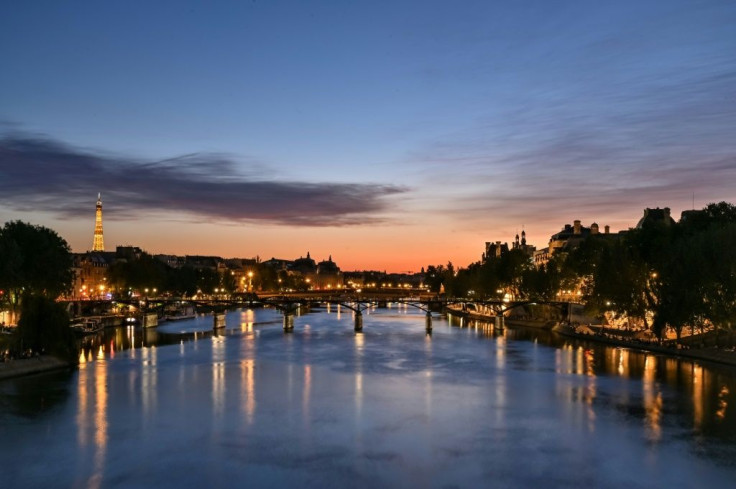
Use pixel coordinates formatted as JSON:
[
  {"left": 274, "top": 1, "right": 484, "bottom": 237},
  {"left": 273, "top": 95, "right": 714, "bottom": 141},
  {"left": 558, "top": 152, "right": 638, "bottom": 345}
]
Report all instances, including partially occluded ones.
[{"left": 0, "top": 306, "right": 736, "bottom": 489}]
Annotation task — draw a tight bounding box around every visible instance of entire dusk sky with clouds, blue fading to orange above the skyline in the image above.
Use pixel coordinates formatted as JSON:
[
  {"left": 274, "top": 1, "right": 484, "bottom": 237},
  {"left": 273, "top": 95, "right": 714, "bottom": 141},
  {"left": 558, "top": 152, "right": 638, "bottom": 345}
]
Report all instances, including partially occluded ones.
[{"left": 0, "top": 0, "right": 736, "bottom": 272}]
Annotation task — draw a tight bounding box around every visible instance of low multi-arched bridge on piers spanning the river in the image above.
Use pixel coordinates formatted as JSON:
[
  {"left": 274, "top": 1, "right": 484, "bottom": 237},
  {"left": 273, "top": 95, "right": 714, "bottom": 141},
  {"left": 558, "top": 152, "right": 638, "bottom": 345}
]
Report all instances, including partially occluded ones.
[{"left": 61, "top": 289, "right": 570, "bottom": 334}]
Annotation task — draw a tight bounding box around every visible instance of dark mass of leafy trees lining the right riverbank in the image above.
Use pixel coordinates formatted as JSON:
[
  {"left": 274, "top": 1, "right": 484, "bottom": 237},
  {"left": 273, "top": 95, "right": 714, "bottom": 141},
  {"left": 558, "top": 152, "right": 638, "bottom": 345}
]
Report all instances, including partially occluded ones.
[{"left": 426, "top": 202, "right": 736, "bottom": 336}]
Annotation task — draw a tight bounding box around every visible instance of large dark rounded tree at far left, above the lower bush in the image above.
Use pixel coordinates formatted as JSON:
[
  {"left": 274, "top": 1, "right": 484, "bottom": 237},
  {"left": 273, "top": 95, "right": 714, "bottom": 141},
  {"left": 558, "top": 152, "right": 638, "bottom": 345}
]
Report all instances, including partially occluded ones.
[{"left": 0, "top": 221, "right": 74, "bottom": 310}]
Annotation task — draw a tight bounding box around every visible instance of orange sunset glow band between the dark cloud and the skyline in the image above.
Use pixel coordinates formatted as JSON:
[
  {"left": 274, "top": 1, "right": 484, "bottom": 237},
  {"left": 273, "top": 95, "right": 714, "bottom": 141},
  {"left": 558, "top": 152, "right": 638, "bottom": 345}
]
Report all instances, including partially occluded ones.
[{"left": 14, "top": 210, "right": 640, "bottom": 273}]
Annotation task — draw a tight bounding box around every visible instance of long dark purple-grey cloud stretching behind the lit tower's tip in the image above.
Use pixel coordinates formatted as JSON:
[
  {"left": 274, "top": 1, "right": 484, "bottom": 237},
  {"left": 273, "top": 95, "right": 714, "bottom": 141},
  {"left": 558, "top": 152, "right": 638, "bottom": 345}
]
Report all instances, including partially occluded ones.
[{"left": 0, "top": 135, "right": 405, "bottom": 226}]
